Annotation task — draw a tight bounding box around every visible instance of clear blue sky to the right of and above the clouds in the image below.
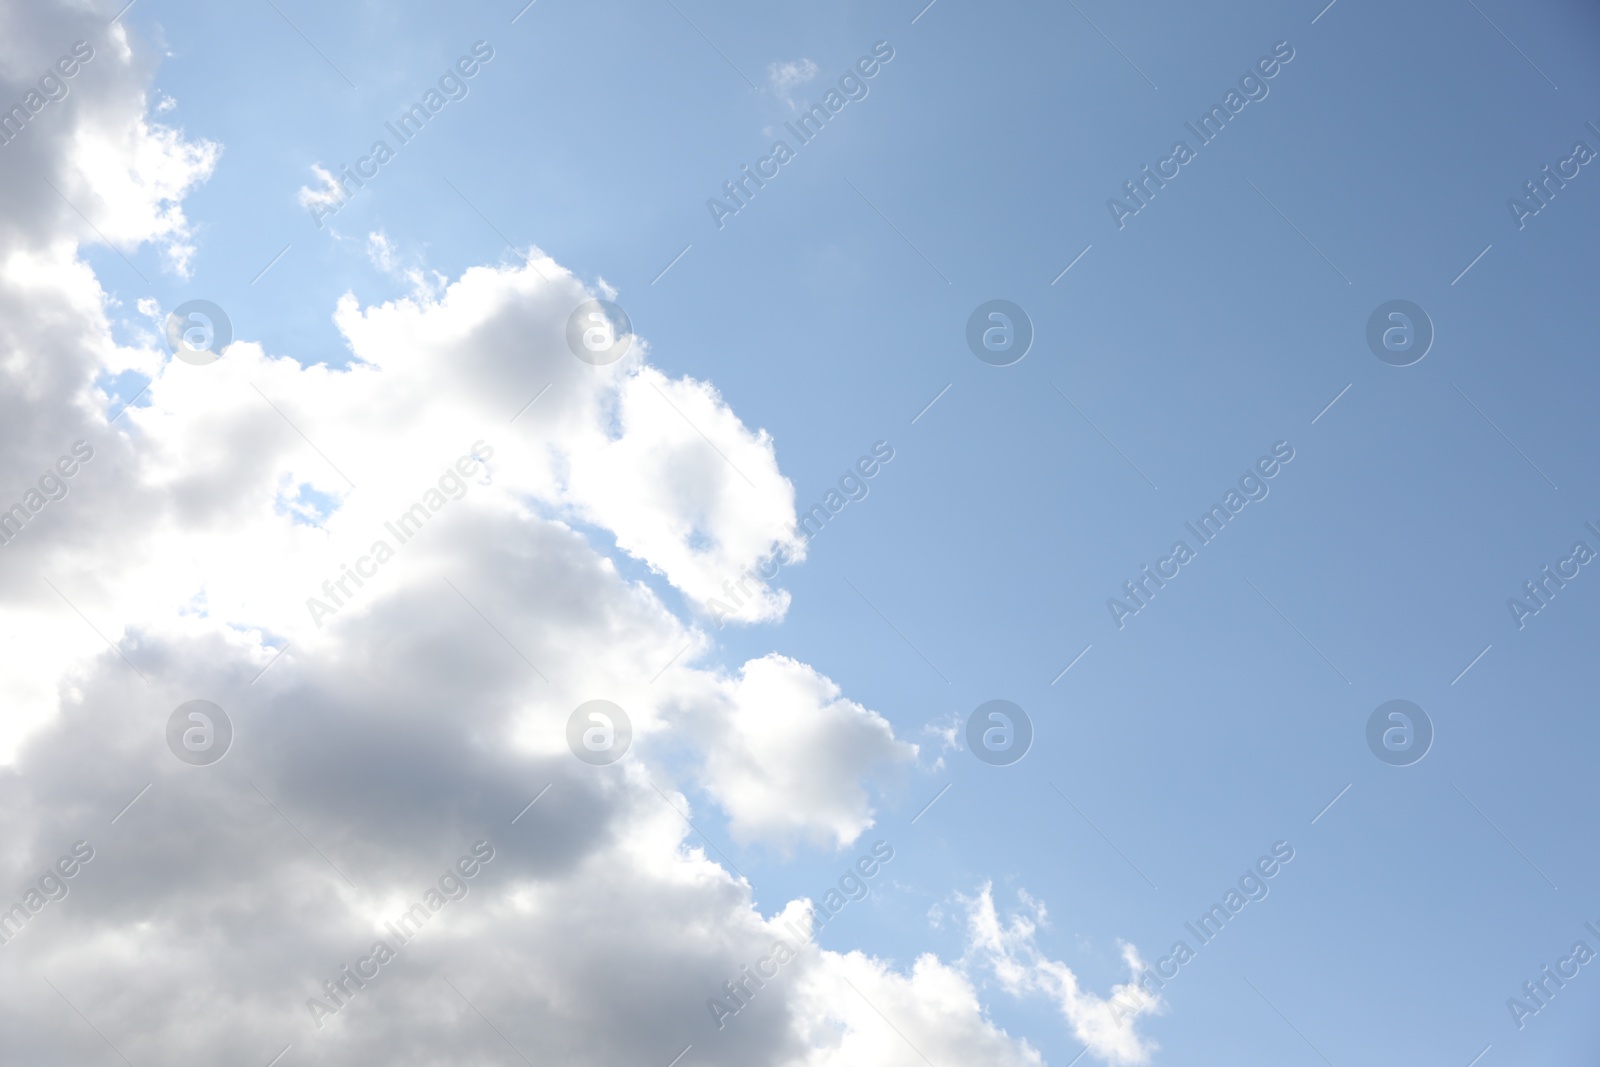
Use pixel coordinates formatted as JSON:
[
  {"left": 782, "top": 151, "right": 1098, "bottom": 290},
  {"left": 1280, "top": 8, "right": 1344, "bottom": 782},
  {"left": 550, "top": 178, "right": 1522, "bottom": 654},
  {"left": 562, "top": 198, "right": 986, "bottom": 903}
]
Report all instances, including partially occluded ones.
[{"left": 12, "top": 0, "right": 1600, "bottom": 1067}]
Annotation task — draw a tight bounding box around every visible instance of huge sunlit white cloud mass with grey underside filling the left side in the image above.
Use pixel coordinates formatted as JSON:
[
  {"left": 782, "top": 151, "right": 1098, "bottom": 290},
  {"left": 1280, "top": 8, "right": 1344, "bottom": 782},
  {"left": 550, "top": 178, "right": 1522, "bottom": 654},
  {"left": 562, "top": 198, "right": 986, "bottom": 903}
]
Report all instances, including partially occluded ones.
[{"left": 0, "top": 5, "right": 1062, "bottom": 1065}]
